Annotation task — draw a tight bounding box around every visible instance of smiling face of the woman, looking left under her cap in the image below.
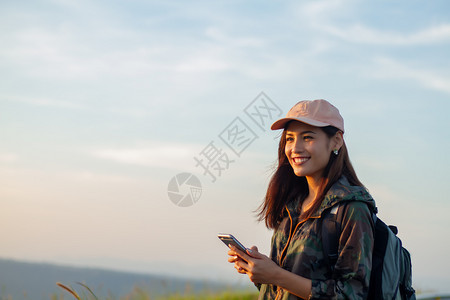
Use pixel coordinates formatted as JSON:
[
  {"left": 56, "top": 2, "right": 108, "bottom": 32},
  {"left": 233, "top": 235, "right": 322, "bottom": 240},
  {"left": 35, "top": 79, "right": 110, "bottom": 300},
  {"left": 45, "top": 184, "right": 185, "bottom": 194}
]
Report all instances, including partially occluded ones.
[{"left": 285, "top": 121, "right": 339, "bottom": 182}]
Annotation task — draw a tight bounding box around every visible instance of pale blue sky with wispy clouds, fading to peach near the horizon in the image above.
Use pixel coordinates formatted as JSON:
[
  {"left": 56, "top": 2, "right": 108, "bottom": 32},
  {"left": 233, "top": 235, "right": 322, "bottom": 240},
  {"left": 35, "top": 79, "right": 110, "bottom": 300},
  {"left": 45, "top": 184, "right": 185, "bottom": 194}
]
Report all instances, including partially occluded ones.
[{"left": 0, "top": 0, "right": 450, "bottom": 290}]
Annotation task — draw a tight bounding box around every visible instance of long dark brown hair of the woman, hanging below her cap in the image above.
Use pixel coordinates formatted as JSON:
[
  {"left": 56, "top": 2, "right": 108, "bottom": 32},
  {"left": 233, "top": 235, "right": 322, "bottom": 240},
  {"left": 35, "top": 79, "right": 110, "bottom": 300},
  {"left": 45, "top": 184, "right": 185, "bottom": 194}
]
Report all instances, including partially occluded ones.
[{"left": 258, "top": 126, "right": 363, "bottom": 229}]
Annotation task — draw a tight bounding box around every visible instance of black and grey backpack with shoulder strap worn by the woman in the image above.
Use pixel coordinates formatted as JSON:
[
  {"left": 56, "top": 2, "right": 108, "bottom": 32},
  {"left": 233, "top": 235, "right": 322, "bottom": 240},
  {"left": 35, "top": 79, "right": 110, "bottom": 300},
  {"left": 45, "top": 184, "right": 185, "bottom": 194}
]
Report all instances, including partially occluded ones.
[{"left": 322, "top": 201, "right": 416, "bottom": 300}]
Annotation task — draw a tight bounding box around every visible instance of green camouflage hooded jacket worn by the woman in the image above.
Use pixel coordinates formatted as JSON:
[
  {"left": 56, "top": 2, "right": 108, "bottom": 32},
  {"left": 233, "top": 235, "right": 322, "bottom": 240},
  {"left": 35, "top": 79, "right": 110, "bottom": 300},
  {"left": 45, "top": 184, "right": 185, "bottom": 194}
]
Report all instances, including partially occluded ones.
[{"left": 259, "top": 177, "right": 375, "bottom": 300}]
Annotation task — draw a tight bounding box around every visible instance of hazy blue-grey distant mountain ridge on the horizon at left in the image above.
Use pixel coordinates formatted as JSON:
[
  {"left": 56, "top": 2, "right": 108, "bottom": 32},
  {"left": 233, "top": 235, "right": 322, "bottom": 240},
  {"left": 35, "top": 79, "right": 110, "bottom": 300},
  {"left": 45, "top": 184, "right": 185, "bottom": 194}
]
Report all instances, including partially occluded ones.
[{"left": 0, "top": 259, "right": 225, "bottom": 300}]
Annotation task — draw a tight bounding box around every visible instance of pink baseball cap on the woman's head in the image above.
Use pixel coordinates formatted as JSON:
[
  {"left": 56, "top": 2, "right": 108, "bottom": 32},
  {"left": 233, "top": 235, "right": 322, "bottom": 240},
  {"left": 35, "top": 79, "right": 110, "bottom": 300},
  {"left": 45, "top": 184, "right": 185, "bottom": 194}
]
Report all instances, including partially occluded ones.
[{"left": 270, "top": 99, "right": 344, "bottom": 132}]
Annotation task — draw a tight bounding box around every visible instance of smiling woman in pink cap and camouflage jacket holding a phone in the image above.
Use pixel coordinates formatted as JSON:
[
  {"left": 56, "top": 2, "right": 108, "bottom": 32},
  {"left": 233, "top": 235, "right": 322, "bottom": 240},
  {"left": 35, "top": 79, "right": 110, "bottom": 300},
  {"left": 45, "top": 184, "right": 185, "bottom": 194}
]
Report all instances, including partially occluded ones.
[{"left": 228, "top": 100, "right": 375, "bottom": 299}]
